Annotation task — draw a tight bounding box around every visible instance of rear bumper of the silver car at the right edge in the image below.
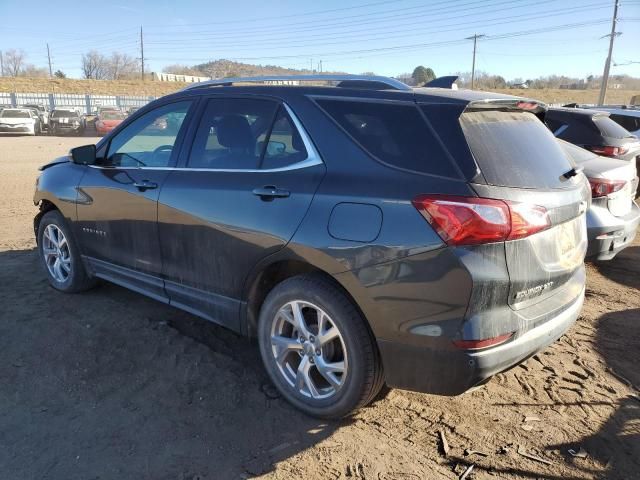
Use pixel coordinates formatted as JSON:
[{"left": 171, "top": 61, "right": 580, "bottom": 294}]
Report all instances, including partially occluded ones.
[{"left": 587, "top": 203, "right": 640, "bottom": 260}]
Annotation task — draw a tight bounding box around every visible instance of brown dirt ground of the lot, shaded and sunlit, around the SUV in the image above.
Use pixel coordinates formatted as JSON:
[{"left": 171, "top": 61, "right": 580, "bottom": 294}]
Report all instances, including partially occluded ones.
[{"left": 0, "top": 137, "right": 640, "bottom": 480}]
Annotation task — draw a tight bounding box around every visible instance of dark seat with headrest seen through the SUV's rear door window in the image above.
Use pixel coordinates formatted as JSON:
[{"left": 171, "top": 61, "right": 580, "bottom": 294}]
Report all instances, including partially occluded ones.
[{"left": 215, "top": 115, "right": 258, "bottom": 169}]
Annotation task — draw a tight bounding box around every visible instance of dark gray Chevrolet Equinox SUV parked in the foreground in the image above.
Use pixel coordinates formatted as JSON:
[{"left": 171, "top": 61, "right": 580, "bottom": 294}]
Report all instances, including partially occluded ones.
[{"left": 34, "top": 76, "right": 590, "bottom": 417}]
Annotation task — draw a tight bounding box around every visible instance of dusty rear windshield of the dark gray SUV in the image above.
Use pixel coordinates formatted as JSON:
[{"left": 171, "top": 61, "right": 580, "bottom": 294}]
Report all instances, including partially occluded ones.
[{"left": 460, "top": 111, "right": 572, "bottom": 188}]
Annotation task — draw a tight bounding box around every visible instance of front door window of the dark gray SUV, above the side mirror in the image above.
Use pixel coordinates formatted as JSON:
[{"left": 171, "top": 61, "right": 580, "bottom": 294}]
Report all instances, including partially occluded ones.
[{"left": 102, "top": 101, "right": 191, "bottom": 167}]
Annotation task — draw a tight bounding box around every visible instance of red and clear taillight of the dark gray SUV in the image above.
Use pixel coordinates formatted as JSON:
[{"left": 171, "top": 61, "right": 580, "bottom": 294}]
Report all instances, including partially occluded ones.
[{"left": 413, "top": 195, "right": 551, "bottom": 245}]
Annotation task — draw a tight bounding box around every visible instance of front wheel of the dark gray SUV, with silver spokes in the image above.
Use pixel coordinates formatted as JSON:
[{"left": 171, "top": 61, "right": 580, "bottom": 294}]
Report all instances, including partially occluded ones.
[{"left": 38, "top": 210, "right": 95, "bottom": 293}]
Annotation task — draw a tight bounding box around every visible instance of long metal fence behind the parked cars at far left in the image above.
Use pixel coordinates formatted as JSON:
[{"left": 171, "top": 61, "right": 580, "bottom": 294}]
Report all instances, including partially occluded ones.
[{"left": 0, "top": 92, "right": 156, "bottom": 115}]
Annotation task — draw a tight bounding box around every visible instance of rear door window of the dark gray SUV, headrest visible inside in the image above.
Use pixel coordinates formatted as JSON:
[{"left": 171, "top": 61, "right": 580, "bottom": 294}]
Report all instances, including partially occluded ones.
[{"left": 189, "top": 98, "right": 278, "bottom": 170}]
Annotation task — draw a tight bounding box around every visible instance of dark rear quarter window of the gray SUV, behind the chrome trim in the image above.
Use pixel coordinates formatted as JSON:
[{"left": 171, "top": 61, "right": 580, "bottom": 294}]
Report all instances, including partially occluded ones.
[{"left": 317, "top": 100, "right": 459, "bottom": 178}]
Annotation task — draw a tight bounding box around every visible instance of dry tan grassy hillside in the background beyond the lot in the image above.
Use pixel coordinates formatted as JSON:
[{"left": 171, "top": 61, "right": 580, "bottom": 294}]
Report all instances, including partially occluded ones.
[{"left": 0, "top": 76, "right": 640, "bottom": 103}]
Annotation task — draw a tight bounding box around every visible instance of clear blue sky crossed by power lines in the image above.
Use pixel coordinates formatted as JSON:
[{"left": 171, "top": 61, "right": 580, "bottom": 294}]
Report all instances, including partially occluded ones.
[{"left": 0, "top": 0, "right": 640, "bottom": 80}]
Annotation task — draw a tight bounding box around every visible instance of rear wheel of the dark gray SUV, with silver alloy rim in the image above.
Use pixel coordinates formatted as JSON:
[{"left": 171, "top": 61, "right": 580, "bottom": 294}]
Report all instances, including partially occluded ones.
[{"left": 258, "top": 274, "right": 383, "bottom": 418}]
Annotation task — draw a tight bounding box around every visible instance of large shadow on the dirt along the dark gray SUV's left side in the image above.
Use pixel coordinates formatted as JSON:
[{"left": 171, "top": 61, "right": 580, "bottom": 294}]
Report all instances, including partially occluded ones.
[{"left": 0, "top": 250, "right": 349, "bottom": 479}]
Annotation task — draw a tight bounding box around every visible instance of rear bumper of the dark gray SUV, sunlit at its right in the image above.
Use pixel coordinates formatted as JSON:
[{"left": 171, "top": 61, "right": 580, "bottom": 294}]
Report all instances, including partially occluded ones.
[{"left": 378, "top": 287, "right": 584, "bottom": 395}]
